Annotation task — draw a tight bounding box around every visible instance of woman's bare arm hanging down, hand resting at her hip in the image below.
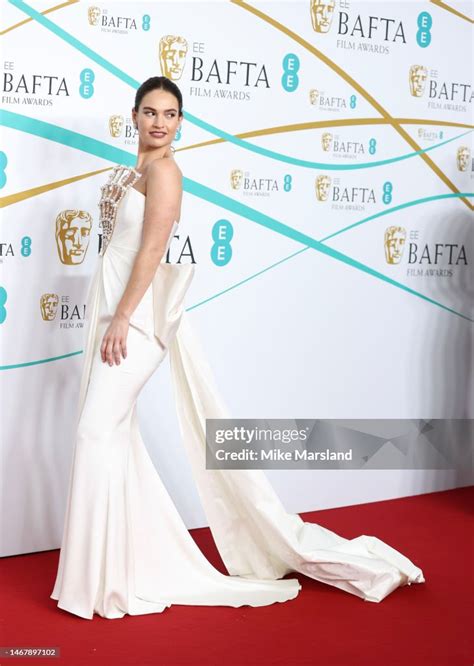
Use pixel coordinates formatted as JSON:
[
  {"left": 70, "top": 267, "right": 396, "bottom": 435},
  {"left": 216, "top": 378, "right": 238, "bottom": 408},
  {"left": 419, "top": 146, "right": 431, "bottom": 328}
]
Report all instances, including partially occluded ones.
[{"left": 100, "top": 158, "right": 183, "bottom": 365}]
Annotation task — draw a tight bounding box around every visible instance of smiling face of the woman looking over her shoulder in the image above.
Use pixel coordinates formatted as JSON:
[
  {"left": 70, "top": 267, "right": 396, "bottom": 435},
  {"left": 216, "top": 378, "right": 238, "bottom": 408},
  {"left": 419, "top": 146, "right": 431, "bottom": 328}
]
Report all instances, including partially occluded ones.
[{"left": 132, "top": 90, "right": 182, "bottom": 149}]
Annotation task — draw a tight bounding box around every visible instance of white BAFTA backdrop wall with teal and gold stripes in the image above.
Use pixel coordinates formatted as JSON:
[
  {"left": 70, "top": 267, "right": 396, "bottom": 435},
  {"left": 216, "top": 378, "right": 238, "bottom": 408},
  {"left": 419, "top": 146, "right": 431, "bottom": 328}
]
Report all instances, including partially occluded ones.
[{"left": 0, "top": 0, "right": 474, "bottom": 555}]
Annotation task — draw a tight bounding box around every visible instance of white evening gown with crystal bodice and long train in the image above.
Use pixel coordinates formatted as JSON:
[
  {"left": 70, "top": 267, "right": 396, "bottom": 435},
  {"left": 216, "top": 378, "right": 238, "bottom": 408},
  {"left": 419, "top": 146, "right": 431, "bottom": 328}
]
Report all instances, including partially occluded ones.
[{"left": 51, "top": 165, "right": 424, "bottom": 619}]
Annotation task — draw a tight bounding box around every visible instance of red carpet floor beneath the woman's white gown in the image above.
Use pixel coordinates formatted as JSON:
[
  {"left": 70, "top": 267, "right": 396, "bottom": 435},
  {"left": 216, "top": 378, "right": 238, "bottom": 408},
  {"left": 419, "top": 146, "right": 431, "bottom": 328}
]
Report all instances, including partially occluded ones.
[{"left": 0, "top": 487, "right": 474, "bottom": 666}]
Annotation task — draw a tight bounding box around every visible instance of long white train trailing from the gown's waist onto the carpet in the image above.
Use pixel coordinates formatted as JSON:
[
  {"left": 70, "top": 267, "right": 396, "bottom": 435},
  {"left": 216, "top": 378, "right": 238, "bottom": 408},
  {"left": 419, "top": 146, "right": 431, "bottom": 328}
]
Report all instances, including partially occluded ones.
[{"left": 170, "top": 313, "right": 425, "bottom": 602}]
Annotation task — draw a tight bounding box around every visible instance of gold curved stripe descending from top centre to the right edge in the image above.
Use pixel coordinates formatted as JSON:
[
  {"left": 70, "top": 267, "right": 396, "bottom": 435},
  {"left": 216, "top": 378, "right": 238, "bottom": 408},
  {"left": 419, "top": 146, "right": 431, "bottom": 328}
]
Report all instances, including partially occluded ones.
[{"left": 230, "top": 0, "right": 474, "bottom": 210}]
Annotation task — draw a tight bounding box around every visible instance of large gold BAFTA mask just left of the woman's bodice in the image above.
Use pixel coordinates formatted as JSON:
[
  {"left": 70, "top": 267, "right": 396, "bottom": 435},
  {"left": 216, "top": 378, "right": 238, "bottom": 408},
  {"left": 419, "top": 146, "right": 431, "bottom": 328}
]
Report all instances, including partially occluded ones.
[{"left": 55, "top": 210, "right": 92, "bottom": 266}]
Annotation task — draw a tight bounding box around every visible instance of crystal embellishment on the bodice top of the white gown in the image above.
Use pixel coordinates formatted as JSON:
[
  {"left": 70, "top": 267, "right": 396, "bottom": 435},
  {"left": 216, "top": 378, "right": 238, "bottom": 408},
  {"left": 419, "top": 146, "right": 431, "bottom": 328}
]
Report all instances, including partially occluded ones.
[{"left": 98, "top": 164, "right": 141, "bottom": 256}]
